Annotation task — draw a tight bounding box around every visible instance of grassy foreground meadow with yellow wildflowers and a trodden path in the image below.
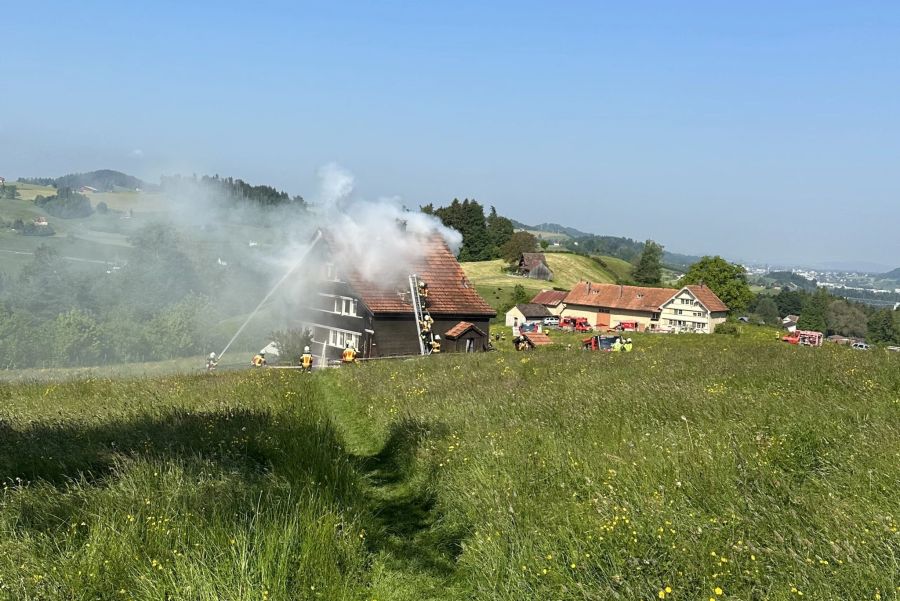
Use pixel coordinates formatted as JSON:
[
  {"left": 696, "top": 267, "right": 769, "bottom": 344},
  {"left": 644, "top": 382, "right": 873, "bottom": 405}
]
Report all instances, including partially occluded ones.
[{"left": 0, "top": 336, "right": 900, "bottom": 601}]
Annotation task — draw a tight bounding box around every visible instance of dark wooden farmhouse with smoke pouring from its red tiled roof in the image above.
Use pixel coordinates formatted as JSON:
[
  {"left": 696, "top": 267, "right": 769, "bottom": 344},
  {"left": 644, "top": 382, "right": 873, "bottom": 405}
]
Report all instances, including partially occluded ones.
[{"left": 301, "top": 234, "right": 497, "bottom": 359}]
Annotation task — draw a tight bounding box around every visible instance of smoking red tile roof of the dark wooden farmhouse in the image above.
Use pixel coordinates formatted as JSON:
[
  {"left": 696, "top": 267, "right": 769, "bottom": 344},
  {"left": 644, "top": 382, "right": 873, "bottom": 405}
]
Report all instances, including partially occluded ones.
[{"left": 323, "top": 233, "right": 497, "bottom": 317}]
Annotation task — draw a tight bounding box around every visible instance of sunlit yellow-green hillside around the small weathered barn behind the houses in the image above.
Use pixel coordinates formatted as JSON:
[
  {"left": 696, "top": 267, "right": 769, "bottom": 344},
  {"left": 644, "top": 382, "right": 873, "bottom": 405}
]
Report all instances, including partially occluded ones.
[{"left": 462, "top": 253, "right": 618, "bottom": 317}]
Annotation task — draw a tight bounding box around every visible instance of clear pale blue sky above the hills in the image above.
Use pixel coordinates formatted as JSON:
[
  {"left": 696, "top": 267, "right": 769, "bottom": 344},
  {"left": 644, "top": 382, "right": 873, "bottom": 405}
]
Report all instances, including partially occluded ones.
[{"left": 0, "top": 0, "right": 900, "bottom": 268}]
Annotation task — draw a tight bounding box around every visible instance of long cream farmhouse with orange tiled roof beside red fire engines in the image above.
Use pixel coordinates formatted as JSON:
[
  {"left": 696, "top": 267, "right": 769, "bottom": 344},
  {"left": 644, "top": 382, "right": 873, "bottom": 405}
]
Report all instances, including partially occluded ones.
[{"left": 561, "top": 282, "right": 728, "bottom": 333}]
